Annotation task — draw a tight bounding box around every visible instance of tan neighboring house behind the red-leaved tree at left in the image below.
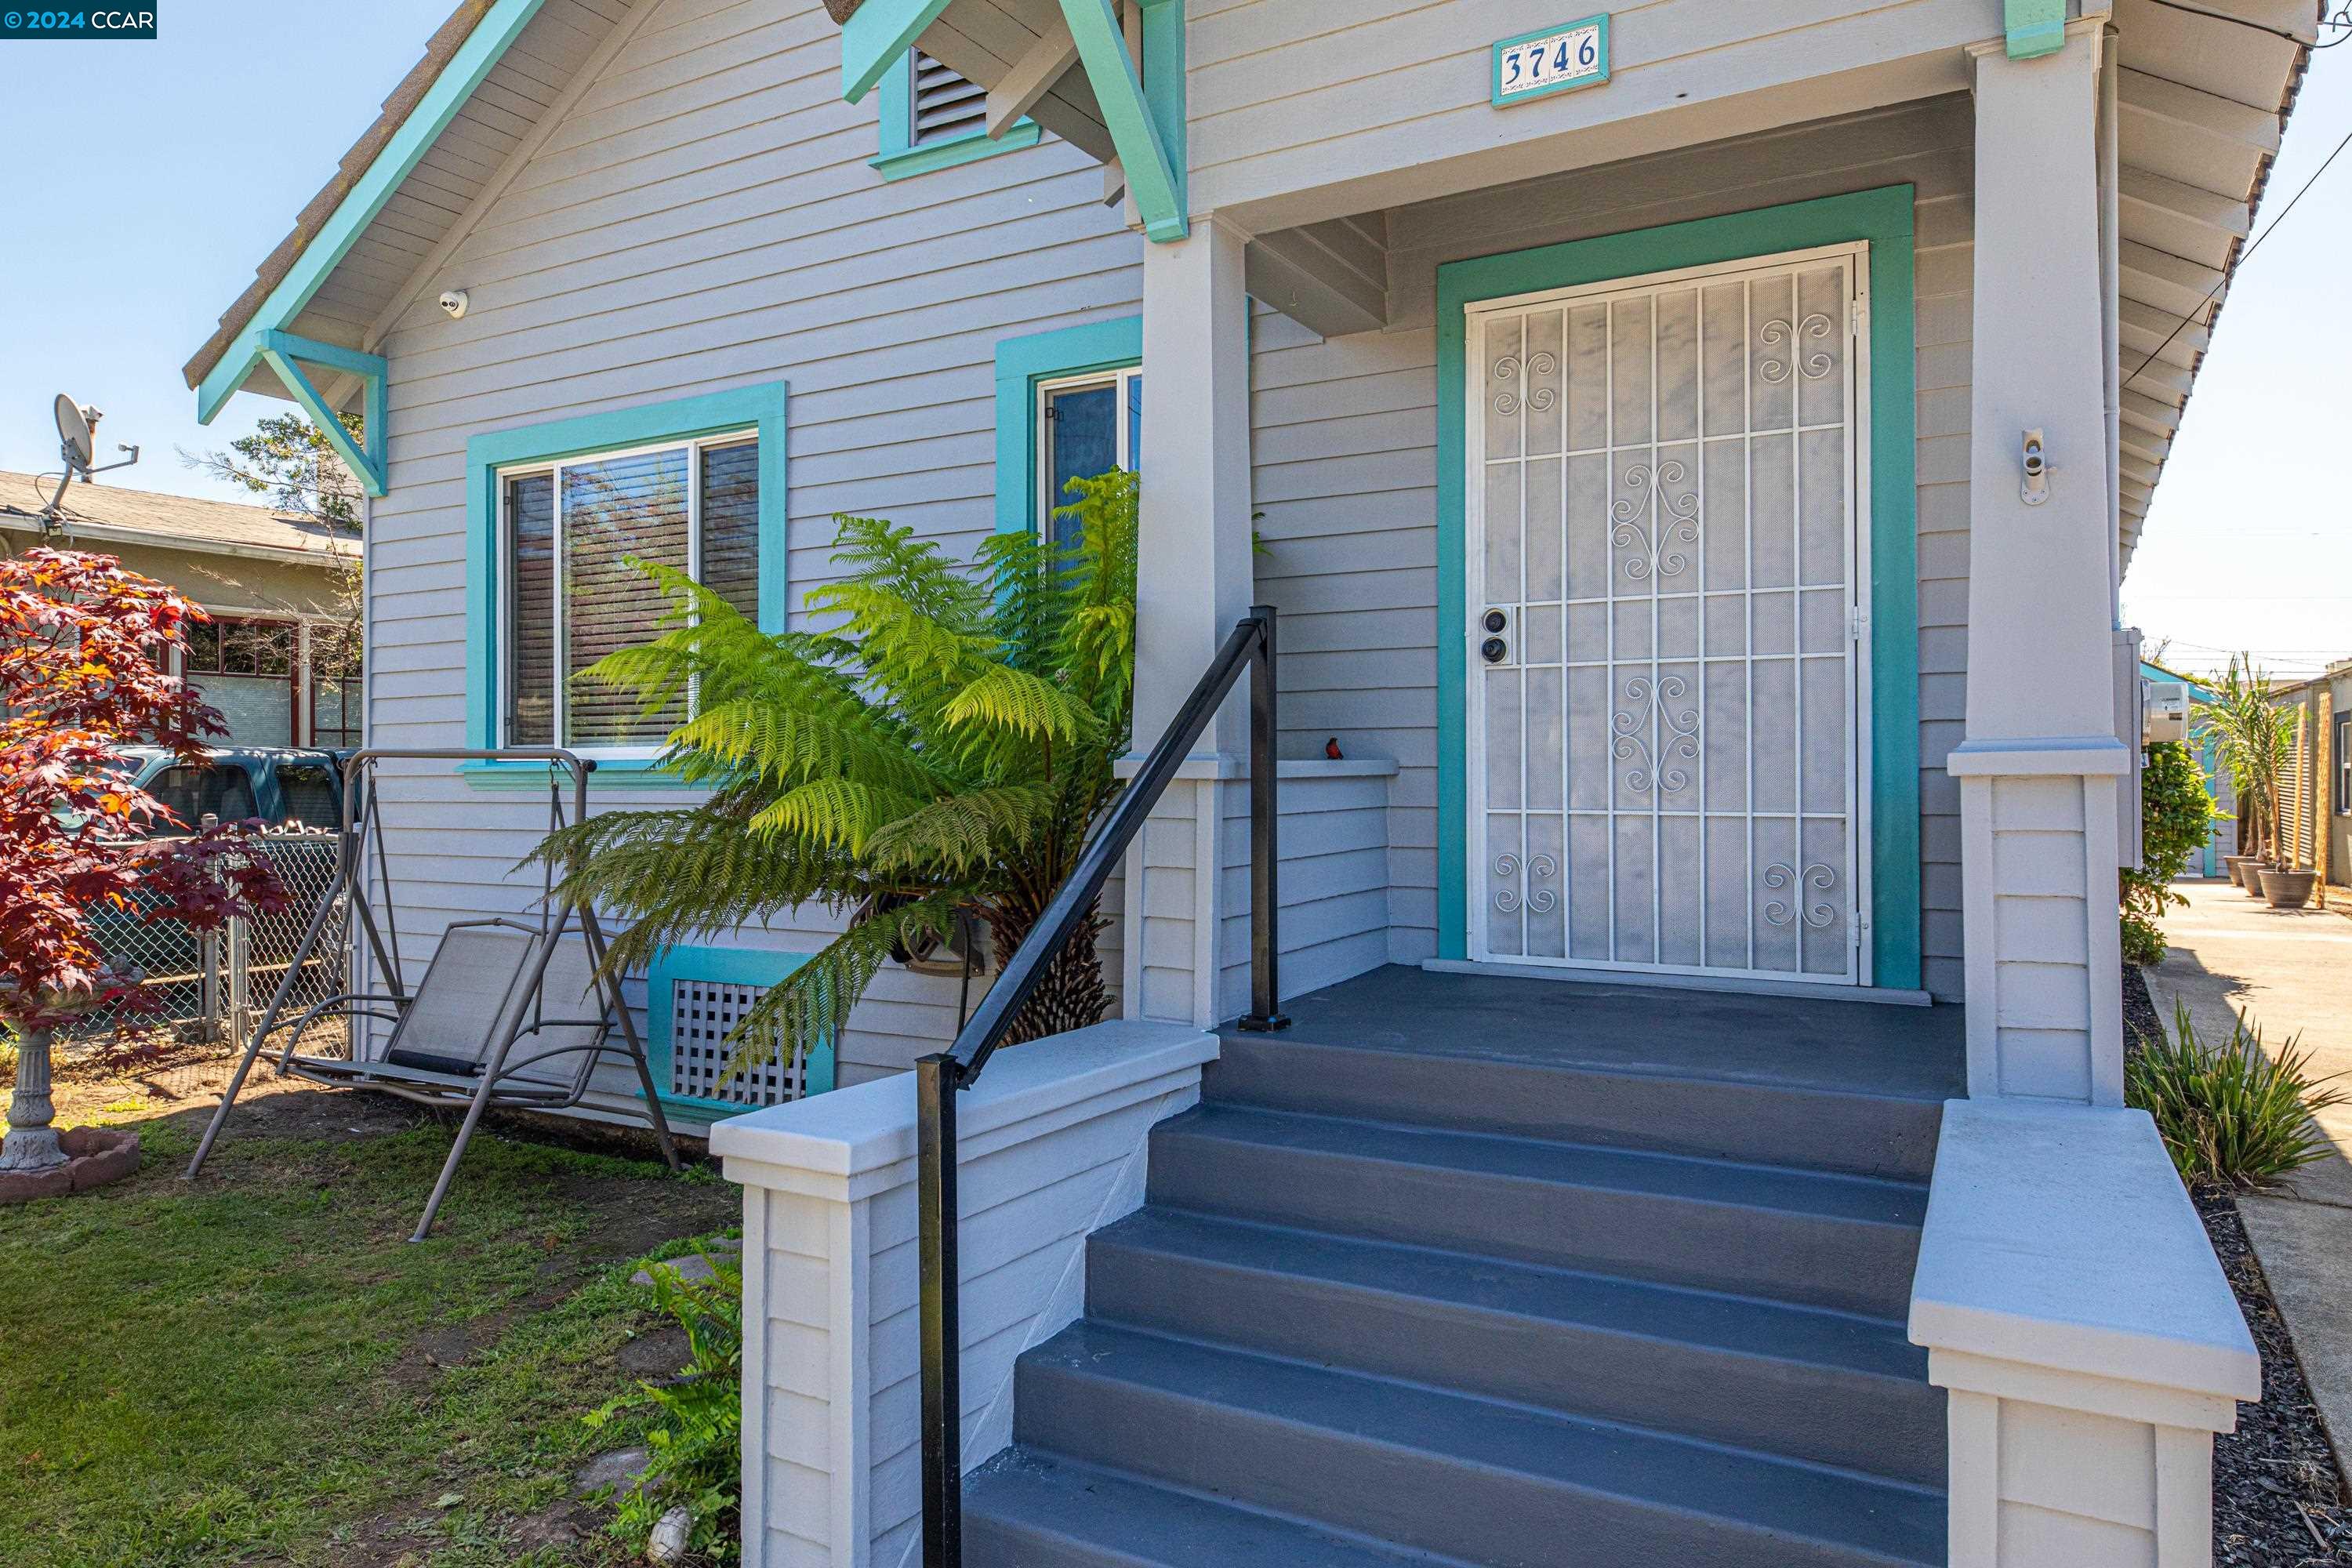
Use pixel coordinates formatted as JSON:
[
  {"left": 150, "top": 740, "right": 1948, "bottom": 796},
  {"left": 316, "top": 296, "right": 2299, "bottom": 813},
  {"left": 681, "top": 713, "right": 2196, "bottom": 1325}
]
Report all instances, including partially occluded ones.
[{"left": 0, "top": 473, "right": 360, "bottom": 748}]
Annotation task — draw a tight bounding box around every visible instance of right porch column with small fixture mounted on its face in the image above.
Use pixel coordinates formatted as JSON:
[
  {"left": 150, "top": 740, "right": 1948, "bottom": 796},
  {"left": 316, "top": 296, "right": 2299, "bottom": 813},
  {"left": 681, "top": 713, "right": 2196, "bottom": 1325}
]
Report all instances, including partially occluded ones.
[{"left": 1950, "top": 19, "right": 2131, "bottom": 1105}]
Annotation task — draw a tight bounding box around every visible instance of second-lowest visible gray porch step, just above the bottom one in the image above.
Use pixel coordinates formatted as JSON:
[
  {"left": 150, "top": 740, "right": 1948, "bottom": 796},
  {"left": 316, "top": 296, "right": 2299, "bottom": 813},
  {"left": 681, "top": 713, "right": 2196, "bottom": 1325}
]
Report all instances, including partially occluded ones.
[{"left": 1009, "top": 1321, "right": 1945, "bottom": 1568}]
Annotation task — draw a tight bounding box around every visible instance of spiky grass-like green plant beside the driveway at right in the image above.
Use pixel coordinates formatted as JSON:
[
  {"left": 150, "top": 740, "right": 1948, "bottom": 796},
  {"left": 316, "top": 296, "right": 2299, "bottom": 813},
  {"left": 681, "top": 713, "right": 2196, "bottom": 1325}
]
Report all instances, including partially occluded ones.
[{"left": 2124, "top": 1001, "right": 2345, "bottom": 1187}]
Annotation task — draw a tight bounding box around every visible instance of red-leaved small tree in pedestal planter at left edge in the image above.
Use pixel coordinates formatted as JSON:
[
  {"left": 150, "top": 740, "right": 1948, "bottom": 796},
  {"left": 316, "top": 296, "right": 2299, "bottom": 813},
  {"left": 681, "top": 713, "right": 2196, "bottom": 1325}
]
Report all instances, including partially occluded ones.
[{"left": 0, "top": 550, "right": 285, "bottom": 1199}]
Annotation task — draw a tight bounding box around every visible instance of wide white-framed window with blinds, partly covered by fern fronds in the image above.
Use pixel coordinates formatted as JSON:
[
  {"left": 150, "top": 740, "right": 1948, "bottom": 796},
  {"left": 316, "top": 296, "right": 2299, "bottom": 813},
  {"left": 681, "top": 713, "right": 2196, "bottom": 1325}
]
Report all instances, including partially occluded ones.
[{"left": 499, "top": 430, "right": 760, "bottom": 755}]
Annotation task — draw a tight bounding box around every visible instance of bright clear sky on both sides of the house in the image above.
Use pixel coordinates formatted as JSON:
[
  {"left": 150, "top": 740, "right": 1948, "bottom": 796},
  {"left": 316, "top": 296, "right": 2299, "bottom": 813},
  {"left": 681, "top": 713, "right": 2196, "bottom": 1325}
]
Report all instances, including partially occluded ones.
[{"left": 0, "top": 0, "right": 2352, "bottom": 673}]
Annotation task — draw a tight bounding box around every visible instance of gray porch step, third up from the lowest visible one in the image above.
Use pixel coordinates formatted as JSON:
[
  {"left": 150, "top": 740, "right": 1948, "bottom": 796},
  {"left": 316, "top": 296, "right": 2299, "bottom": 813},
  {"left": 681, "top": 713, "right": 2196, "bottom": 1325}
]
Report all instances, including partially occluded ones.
[{"left": 1087, "top": 1208, "right": 1945, "bottom": 1486}]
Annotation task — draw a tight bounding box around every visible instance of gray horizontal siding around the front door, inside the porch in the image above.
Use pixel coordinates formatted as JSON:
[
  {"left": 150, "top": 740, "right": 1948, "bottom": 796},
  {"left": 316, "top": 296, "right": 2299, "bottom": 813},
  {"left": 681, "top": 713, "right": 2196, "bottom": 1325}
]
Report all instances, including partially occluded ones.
[{"left": 1251, "top": 99, "right": 1973, "bottom": 996}]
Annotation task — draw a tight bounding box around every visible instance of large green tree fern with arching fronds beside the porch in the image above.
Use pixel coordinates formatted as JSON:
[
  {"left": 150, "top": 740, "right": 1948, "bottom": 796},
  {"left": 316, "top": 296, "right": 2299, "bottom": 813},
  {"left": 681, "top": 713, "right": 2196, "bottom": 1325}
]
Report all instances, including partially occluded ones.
[{"left": 536, "top": 470, "right": 1136, "bottom": 1069}]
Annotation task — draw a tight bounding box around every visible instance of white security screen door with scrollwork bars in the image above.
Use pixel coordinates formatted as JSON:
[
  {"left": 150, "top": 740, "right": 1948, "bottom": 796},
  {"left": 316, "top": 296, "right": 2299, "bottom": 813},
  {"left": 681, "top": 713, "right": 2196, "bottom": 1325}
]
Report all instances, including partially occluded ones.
[{"left": 1465, "top": 247, "right": 1870, "bottom": 985}]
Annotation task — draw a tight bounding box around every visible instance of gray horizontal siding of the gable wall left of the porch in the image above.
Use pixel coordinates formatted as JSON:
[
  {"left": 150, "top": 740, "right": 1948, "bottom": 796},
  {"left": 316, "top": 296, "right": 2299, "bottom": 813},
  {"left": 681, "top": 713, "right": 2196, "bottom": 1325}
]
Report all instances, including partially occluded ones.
[{"left": 369, "top": 0, "right": 1141, "bottom": 1083}]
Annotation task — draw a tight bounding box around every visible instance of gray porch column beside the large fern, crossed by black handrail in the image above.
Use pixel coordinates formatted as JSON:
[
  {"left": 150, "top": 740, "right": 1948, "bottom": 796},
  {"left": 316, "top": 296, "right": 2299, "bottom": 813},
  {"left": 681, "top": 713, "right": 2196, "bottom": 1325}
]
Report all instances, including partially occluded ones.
[{"left": 1122, "top": 214, "right": 1254, "bottom": 1025}]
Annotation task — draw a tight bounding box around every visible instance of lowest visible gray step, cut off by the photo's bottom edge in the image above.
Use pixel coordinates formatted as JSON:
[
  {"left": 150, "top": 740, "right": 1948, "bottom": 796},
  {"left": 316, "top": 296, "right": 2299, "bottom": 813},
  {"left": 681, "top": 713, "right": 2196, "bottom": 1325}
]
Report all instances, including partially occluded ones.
[{"left": 964, "top": 1446, "right": 1454, "bottom": 1568}]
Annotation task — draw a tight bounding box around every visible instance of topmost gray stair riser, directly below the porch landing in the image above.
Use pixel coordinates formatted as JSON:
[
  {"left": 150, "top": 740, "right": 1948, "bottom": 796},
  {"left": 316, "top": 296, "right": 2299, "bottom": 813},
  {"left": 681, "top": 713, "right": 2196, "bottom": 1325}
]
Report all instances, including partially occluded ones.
[{"left": 1202, "top": 1029, "right": 1945, "bottom": 1182}]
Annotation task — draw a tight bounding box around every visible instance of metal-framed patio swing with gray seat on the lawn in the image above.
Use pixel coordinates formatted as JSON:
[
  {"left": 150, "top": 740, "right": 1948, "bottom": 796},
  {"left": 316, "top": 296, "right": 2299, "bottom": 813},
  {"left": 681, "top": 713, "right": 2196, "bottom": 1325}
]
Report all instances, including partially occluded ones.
[{"left": 186, "top": 748, "right": 680, "bottom": 1241}]
